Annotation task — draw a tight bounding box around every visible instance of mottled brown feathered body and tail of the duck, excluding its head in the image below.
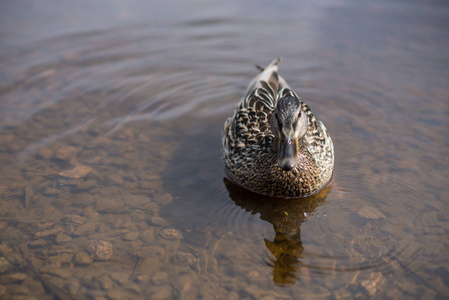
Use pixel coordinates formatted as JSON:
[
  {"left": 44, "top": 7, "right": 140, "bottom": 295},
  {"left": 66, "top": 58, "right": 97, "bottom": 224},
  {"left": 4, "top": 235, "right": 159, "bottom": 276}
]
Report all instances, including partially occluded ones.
[{"left": 222, "top": 61, "right": 334, "bottom": 197}]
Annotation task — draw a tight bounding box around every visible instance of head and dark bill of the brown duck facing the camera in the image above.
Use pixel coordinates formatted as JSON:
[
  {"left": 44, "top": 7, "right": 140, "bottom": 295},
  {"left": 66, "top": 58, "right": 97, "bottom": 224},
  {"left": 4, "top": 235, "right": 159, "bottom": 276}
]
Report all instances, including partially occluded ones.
[{"left": 271, "top": 95, "right": 308, "bottom": 171}]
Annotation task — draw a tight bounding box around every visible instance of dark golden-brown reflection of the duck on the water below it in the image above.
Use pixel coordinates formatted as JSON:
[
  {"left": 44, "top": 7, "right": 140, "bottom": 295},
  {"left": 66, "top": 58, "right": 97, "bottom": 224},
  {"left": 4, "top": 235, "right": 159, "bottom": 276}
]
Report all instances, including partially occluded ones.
[{"left": 224, "top": 178, "right": 331, "bottom": 286}]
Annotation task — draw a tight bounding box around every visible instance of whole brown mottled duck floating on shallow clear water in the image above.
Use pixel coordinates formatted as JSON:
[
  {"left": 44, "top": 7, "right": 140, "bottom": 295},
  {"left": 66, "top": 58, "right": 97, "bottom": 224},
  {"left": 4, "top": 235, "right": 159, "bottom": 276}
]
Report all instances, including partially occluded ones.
[{"left": 222, "top": 58, "right": 334, "bottom": 198}]
